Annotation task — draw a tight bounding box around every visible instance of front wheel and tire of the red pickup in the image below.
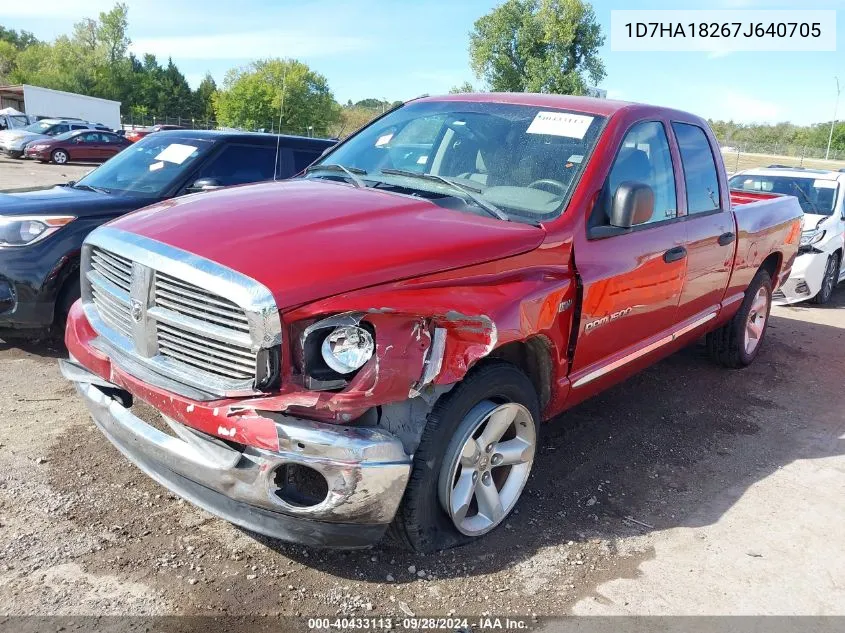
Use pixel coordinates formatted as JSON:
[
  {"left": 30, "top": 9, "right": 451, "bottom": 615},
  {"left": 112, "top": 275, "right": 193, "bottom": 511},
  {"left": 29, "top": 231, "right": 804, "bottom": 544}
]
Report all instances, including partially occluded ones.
[{"left": 391, "top": 361, "right": 540, "bottom": 552}]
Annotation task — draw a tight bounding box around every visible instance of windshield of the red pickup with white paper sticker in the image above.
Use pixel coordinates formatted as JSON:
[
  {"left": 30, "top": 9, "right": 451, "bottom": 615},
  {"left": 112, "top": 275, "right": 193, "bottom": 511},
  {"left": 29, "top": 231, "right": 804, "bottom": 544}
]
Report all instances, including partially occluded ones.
[{"left": 306, "top": 101, "right": 604, "bottom": 222}]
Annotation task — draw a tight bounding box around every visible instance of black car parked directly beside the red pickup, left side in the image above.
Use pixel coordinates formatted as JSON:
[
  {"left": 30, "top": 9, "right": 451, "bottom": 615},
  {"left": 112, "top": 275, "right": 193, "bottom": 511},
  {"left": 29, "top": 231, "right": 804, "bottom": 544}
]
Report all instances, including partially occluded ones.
[{"left": 0, "top": 131, "right": 334, "bottom": 328}]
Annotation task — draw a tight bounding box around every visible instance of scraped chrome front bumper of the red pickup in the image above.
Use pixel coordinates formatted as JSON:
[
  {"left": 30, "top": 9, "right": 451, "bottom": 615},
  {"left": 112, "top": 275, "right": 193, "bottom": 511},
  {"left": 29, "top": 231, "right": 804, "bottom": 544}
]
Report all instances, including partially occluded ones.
[{"left": 59, "top": 361, "right": 411, "bottom": 547}]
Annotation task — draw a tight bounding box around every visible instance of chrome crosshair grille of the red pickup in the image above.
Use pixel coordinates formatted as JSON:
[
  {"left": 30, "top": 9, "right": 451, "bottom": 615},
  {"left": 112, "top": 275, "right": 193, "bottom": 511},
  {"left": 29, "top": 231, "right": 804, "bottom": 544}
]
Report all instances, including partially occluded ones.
[{"left": 82, "top": 227, "right": 281, "bottom": 396}]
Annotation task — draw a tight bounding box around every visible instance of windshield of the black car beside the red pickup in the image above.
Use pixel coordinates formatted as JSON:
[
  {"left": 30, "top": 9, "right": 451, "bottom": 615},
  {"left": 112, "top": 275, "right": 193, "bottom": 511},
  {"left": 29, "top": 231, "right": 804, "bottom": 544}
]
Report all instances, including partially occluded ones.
[{"left": 74, "top": 134, "right": 214, "bottom": 198}]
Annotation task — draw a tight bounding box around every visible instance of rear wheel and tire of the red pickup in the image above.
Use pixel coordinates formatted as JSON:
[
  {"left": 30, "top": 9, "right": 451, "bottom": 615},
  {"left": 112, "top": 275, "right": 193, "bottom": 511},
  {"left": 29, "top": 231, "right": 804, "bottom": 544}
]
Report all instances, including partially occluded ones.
[{"left": 707, "top": 270, "right": 772, "bottom": 369}]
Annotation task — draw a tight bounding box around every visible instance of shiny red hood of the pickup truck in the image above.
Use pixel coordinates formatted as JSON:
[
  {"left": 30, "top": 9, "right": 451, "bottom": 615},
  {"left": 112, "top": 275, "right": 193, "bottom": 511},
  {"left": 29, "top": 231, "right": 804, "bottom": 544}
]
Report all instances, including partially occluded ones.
[{"left": 111, "top": 180, "right": 545, "bottom": 309}]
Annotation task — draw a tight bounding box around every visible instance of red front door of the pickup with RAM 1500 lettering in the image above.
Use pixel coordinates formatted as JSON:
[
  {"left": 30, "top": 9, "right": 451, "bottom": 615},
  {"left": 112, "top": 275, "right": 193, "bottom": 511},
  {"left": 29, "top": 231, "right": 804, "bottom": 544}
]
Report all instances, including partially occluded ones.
[{"left": 570, "top": 121, "right": 686, "bottom": 401}]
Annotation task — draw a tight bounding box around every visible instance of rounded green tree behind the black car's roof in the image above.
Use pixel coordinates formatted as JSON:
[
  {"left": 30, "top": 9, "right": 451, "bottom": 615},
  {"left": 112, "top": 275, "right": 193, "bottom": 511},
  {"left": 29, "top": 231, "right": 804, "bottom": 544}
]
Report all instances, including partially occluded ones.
[{"left": 214, "top": 59, "right": 340, "bottom": 136}]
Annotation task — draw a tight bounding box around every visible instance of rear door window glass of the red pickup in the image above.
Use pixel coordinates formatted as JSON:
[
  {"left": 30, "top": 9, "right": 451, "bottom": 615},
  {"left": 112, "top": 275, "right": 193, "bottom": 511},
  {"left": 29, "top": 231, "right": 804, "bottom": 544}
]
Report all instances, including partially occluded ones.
[{"left": 672, "top": 123, "right": 721, "bottom": 215}]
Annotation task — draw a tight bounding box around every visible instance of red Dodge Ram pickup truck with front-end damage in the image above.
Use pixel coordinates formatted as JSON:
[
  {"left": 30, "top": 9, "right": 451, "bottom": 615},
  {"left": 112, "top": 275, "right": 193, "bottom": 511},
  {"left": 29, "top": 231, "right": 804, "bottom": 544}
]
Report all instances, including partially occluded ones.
[{"left": 61, "top": 94, "right": 802, "bottom": 551}]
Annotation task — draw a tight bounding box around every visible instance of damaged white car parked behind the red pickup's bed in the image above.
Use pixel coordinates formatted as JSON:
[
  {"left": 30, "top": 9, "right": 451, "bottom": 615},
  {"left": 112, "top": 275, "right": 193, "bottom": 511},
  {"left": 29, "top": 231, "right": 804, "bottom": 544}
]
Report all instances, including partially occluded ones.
[{"left": 730, "top": 167, "right": 845, "bottom": 304}]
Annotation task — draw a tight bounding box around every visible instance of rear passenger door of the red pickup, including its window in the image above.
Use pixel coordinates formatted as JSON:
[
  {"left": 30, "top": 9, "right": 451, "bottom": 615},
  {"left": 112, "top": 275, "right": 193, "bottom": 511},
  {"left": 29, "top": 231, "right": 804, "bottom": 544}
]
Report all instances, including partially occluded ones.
[{"left": 672, "top": 121, "right": 736, "bottom": 322}]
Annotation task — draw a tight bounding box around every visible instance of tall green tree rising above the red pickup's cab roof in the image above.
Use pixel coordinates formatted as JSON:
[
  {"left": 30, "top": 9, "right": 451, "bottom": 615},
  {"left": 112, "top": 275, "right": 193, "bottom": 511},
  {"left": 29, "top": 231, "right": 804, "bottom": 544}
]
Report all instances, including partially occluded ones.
[{"left": 469, "top": 0, "right": 605, "bottom": 95}]
